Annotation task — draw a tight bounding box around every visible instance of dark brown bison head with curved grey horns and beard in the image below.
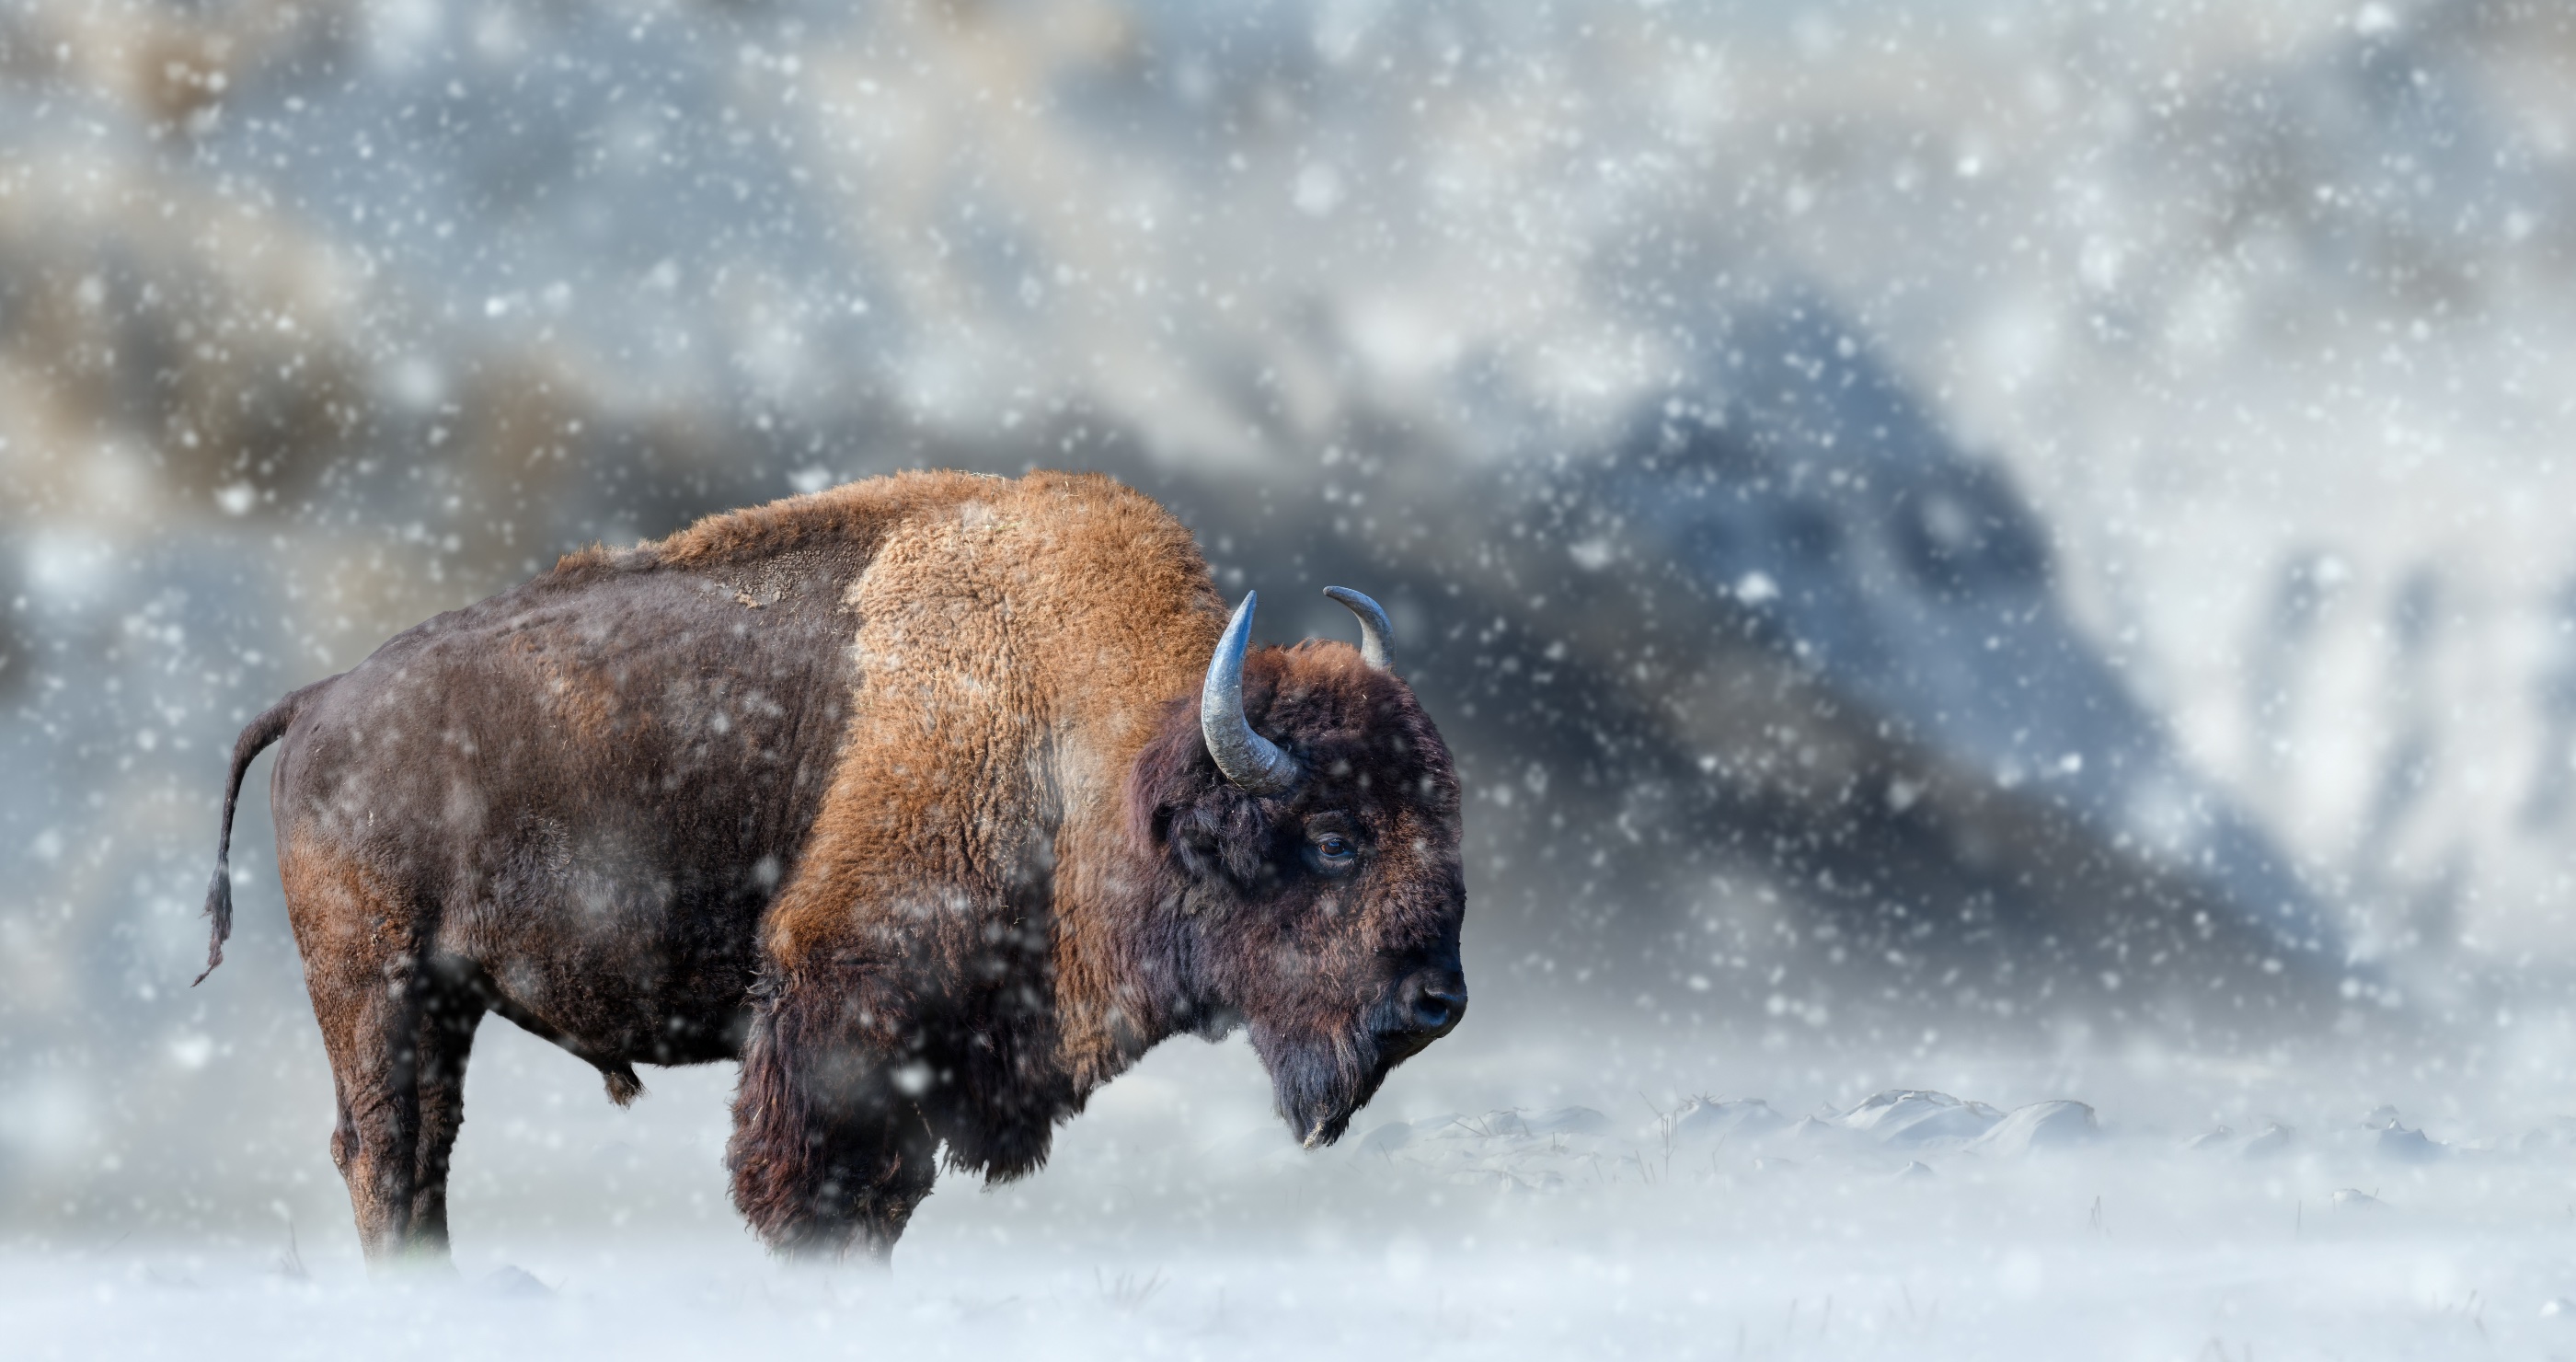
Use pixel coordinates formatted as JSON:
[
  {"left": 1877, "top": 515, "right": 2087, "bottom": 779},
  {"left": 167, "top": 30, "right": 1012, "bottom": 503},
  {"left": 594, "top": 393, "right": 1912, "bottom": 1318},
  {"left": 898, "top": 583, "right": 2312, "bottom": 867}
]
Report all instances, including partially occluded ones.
[{"left": 1131, "top": 587, "right": 1466, "bottom": 1148}]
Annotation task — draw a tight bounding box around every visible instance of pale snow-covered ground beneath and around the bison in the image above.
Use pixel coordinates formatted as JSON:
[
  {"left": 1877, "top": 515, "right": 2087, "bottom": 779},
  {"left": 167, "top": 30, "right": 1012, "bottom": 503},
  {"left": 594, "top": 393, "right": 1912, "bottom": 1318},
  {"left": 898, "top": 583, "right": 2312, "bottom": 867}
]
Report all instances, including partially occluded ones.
[{"left": 15, "top": 1037, "right": 2576, "bottom": 1359}]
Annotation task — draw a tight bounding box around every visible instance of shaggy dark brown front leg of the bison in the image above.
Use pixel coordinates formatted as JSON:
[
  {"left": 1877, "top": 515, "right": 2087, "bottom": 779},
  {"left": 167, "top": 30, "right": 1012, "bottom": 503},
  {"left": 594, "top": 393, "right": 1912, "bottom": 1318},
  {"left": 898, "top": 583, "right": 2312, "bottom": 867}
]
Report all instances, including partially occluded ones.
[{"left": 724, "top": 981, "right": 937, "bottom": 1262}]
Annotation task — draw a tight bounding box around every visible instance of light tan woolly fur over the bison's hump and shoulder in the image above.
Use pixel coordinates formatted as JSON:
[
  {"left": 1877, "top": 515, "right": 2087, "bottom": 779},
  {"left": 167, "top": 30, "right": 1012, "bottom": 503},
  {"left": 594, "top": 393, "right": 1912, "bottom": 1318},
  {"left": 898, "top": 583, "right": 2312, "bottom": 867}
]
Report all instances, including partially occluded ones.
[{"left": 747, "top": 474, "right": 1224, "bottom": 1089}]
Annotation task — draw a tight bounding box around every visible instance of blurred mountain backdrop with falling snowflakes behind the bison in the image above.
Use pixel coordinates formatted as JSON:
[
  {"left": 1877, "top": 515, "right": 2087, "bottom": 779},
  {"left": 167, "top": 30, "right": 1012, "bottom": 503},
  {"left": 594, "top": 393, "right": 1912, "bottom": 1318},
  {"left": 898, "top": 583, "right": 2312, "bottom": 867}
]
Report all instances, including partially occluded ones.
[{"left": 0, "top": 0, "right": 2576, "bottom": 1236}]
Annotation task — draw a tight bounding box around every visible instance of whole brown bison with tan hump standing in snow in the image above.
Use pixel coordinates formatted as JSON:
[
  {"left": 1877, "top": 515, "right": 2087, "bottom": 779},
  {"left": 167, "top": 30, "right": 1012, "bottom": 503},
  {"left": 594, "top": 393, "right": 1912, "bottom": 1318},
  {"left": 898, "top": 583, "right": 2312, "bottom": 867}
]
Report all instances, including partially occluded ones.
[{"left": 199, "top": 474, "right": 1468, "bottom": 1262}]
